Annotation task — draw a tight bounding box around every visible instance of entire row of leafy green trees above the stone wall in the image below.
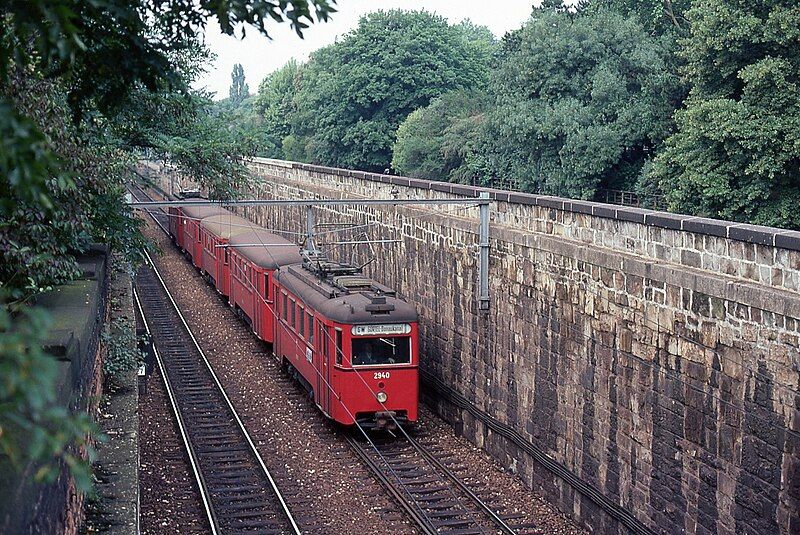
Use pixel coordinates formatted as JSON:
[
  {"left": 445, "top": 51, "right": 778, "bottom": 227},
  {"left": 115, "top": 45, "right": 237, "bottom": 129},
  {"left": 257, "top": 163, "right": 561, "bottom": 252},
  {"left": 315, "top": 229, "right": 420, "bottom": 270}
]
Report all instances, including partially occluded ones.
[{"left": 225, "top": 0, "right": 800, "bottom": 228}]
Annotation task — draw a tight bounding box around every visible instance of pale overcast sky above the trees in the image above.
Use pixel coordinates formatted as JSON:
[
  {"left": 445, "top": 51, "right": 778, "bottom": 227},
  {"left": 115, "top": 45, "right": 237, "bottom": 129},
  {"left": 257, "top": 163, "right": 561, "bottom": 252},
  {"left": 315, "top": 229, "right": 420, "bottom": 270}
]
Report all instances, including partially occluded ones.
[{"left": 195, "top": 0, "right": 539, "bottom": 99}]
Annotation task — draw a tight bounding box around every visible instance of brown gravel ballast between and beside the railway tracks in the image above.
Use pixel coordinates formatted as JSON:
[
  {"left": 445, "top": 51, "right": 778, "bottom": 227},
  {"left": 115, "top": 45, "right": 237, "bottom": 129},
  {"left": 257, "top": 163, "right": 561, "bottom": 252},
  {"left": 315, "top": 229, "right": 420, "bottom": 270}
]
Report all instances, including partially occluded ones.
[{"left": 142, "top": 210, "right": 584, "bottom": 534}]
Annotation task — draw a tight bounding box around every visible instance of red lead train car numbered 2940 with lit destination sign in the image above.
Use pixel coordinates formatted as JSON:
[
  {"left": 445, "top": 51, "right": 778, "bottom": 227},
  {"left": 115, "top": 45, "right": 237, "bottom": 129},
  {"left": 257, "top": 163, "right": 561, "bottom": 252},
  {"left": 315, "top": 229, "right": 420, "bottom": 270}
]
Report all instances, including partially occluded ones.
[{"left": 273, "top": 256, "right": 419, "bottom": 429}]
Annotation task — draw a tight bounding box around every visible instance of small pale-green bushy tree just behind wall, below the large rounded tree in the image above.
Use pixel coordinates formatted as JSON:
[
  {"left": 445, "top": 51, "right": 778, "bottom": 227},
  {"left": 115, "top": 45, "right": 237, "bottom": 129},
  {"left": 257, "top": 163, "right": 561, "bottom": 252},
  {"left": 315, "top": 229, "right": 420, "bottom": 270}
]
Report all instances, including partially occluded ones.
[{"left": 392, "top": 90, "right": 486, "bottom": 183}]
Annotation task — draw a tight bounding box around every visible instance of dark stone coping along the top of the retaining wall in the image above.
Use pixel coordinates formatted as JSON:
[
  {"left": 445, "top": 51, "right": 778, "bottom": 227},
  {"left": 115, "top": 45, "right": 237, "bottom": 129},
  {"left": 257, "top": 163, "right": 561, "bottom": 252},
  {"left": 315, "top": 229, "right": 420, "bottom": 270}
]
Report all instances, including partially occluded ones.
[{"left": 251, "top": 158, "right": 800, "bottom": 251}]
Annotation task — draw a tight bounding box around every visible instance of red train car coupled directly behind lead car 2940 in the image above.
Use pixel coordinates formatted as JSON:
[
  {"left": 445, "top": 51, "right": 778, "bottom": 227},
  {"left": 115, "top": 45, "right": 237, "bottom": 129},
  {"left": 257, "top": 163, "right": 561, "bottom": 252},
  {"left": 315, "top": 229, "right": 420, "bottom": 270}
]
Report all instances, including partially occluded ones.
[{"left": 229, "top": 229, "right": 302, "bottom": 343}]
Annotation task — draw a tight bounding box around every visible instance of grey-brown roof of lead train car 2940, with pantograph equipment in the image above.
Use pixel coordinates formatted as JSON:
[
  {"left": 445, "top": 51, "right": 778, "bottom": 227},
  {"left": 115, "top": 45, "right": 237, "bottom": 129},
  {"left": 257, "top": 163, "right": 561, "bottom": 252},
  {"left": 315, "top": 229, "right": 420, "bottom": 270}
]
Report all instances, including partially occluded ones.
[{"left": 276, "top": 264, "right": 419, "bottom": 325}]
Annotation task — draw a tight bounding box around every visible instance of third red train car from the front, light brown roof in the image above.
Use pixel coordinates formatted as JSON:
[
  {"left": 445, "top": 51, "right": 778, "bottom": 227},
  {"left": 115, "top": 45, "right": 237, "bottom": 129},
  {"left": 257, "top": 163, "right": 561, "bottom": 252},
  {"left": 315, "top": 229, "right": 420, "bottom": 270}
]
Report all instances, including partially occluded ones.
[{"left": 197, "top": 212, "right": 253, "bottom": 297}]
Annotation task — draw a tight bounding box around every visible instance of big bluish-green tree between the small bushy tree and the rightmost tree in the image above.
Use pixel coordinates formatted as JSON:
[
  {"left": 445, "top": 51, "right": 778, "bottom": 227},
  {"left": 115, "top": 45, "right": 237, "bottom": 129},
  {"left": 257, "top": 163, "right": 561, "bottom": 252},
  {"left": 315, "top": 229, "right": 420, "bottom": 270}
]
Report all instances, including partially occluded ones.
[{"left": 476, "top": 8, "right": 683, "bottom": 199}]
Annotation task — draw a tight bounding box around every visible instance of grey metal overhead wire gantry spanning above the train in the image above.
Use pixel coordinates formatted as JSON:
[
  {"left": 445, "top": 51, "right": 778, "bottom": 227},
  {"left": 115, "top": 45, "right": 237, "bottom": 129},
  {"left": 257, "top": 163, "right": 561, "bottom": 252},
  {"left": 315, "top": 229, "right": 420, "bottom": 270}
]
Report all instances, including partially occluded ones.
[{"left": 127, "top": 195, "right": 492, "bottom": 310}]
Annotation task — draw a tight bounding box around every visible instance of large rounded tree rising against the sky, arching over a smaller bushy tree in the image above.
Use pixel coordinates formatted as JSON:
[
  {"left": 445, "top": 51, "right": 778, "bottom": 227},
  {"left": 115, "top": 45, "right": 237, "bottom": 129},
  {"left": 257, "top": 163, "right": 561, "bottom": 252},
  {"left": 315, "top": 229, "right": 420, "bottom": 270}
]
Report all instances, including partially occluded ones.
[{"left": 291, "top": 11, "right": 490, "bottom": 171}]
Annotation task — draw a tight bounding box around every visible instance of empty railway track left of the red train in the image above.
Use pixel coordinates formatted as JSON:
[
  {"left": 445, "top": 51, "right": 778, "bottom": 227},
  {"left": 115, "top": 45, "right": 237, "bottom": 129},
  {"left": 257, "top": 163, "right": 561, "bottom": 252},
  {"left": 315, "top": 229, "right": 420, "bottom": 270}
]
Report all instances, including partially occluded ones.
[{"left": 134, "top": 250, "right": 301, "bottom": 535}]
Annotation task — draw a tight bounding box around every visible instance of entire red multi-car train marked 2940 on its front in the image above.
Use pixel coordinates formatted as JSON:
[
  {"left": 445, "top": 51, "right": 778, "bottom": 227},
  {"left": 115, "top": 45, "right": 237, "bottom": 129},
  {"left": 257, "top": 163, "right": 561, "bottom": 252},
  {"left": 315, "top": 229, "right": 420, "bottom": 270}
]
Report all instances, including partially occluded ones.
[{"left": 169, "top": 201, "right": 419, "bottom": 429}]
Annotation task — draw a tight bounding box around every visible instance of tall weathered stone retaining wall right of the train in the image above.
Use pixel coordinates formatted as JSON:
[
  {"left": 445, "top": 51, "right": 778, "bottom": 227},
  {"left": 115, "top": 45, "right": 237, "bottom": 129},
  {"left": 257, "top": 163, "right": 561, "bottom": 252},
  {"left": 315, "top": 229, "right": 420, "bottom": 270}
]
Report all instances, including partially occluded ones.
[{"left": 153, "top": 159, "right": 800, "bottom": 534}]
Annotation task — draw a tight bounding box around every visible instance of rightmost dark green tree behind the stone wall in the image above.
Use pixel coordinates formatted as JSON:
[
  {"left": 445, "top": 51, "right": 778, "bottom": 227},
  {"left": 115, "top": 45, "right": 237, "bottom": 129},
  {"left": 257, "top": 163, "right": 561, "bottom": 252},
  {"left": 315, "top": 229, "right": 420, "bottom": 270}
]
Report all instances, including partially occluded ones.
[{"left": 649, "top": 0, "right": 800, "bottom": 228}]
